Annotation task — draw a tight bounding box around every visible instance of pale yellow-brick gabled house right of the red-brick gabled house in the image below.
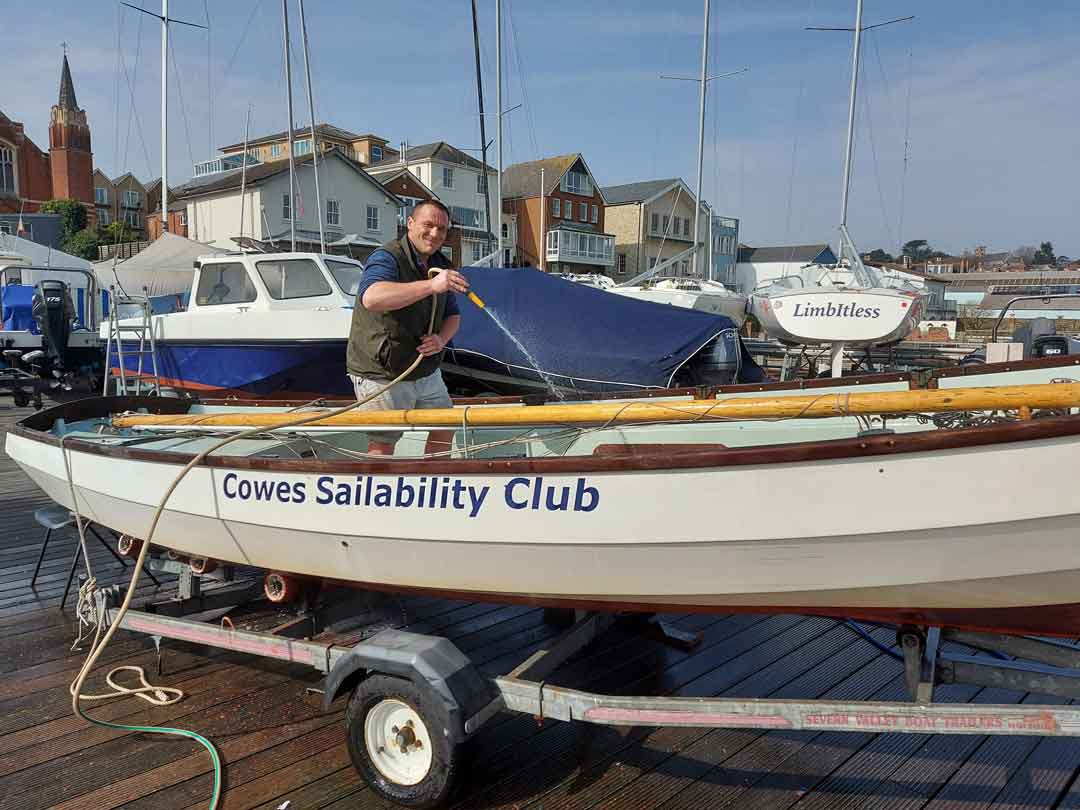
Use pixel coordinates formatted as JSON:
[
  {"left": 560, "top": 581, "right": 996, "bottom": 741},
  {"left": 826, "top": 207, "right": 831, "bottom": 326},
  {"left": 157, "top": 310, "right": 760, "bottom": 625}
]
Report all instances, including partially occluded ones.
[{"left": 604, "top": 177, "right": 725, "bottom": 281}]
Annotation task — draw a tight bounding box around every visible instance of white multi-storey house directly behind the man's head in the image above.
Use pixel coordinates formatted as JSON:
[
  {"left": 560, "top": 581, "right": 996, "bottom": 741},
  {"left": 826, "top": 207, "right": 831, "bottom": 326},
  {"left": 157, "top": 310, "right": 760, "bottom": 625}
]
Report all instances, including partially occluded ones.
[{"left": 368, "top": 140, "right": 494, "bottom": 265}]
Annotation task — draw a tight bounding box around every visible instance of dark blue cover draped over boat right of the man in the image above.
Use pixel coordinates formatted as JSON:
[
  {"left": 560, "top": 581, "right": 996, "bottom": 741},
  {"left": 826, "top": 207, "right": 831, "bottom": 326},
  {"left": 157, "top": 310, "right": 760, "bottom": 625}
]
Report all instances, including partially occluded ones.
[{"left": 449, "top": 267, "right": 765, "bottom": 391}]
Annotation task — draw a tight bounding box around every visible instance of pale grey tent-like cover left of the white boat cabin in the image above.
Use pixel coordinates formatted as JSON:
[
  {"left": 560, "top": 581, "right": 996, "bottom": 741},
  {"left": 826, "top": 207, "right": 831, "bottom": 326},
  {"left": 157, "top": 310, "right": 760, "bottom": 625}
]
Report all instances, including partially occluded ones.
[{"left": 94, "top": 232, "right": 225, "bottom": 297}]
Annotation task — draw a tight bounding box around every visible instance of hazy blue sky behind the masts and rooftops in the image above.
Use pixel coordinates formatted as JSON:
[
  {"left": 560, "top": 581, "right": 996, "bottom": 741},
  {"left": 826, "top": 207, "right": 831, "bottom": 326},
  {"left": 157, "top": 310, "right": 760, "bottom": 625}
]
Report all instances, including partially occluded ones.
[{"left": 8, "top": 0, "right": 1080, "bottom": 257}]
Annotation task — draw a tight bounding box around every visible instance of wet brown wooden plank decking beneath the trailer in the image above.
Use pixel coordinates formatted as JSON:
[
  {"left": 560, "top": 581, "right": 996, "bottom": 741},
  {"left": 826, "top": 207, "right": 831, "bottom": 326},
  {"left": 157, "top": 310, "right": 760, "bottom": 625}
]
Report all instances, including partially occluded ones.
[{"left": 0, "top": 401, "right": 1080, "bottom": 810}]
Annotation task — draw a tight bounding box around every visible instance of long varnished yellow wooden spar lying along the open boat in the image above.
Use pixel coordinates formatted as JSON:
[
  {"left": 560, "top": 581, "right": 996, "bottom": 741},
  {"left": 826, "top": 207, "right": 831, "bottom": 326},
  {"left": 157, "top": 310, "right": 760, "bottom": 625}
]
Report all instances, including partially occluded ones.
[{"left": 112, "top": 382, "right": 1080, "bottom": 430}]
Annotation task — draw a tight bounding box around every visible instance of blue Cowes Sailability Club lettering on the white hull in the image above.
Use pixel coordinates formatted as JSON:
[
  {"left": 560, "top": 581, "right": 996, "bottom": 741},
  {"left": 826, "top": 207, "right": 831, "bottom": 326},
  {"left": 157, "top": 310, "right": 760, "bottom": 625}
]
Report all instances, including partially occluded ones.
[{"left": 221, "top": 472, "right": 600, "bottom": 517}]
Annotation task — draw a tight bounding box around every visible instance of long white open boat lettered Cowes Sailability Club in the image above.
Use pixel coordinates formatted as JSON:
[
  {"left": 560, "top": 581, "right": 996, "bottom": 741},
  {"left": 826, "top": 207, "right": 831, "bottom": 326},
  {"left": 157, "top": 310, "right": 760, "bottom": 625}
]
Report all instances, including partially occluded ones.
[{"left": 6, "top": 383, "right": 1080, "bottom": 636}]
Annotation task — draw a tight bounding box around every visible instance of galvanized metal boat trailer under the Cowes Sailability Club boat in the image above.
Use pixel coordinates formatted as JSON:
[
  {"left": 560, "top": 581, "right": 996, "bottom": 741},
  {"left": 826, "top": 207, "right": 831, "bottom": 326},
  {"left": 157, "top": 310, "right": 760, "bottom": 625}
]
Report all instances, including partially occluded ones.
[{"left": 97, "top": 557, "right": 1080, "bottom": 807}]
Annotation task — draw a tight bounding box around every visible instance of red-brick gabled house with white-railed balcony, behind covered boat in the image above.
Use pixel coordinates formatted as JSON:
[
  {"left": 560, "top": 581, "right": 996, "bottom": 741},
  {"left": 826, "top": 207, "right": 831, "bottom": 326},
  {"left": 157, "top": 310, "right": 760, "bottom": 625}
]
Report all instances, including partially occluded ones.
[{"left": 502, "top": 153, "right": 615, "bottom": 273}]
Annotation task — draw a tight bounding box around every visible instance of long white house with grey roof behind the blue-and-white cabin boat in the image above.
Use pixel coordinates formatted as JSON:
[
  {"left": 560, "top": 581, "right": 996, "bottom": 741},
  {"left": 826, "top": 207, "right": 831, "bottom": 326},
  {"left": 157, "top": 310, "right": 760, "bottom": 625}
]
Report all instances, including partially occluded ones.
[{"left": 175, "top": 150, "right": 403, "bottom": 255}]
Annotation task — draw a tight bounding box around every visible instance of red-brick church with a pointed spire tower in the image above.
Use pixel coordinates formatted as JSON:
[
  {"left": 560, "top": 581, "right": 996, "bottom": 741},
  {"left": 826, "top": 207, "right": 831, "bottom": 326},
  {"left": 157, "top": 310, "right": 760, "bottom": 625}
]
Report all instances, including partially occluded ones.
[{"left": 0, "top": 54, "right": 96, "bottom": 222}]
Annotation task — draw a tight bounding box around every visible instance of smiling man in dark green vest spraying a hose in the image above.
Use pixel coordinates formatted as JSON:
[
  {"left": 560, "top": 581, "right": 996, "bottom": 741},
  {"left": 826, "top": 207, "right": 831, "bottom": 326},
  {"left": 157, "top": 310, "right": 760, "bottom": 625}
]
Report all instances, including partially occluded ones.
[{"left": 346, "top": 200, "right": 469, "bottom": 456}]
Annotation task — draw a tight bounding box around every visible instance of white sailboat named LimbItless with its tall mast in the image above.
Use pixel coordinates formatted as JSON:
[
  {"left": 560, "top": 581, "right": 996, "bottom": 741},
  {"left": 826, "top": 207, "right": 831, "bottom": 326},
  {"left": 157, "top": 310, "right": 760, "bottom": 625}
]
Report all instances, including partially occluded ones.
[{"left": 750, "top": 0, "right": 926, "bottom": 377}]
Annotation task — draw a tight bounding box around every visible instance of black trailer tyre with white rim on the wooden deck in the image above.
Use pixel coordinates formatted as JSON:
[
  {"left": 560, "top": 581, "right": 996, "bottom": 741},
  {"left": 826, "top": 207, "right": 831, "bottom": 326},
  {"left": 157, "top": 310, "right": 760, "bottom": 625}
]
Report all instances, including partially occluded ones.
[{"left": 345, "top": 675, "right": 458, "bottom": 809}]
